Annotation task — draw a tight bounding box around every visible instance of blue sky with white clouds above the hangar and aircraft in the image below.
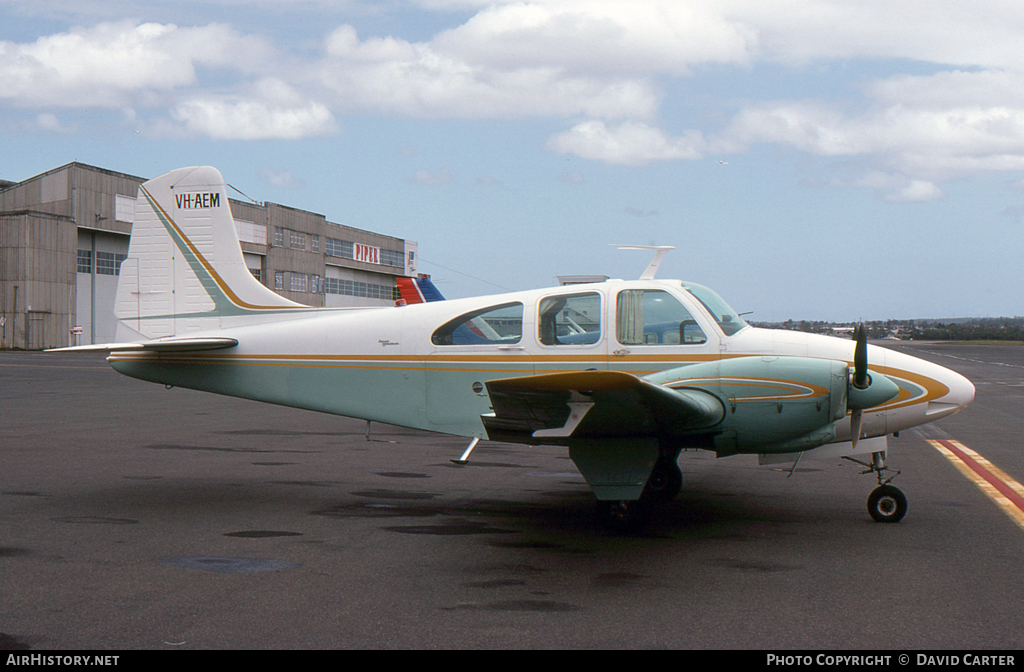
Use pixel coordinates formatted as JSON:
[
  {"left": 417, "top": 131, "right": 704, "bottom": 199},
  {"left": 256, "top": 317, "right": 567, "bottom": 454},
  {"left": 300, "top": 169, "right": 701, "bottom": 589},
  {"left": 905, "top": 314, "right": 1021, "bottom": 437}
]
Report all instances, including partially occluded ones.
[{"left": 0, "top": 0, "right": 1024, "bottom": 321}]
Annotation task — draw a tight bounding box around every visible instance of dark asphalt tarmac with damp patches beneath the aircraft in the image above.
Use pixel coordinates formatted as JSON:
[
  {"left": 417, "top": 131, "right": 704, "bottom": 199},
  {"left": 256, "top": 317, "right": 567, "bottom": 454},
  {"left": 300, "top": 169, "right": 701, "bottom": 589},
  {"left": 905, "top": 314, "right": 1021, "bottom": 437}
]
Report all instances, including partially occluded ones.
[{"left": 0, "top": 343, "right": 1024, "bottom": 652}]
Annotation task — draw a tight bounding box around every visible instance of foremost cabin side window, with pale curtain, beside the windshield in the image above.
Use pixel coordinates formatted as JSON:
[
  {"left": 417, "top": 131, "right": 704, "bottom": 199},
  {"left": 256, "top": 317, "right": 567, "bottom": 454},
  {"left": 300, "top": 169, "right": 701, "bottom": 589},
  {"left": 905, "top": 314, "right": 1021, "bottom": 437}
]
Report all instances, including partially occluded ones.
[{"left": 615, "top": 289, "right": 708, "bottom": 345}]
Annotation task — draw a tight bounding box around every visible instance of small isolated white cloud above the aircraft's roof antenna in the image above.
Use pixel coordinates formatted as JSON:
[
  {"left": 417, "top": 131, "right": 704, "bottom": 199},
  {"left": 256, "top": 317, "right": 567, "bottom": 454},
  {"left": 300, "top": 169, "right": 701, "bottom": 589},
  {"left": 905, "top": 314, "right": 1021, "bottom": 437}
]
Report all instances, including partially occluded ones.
[{"left": 546, "top": 121, "right": 705, "bottom": 166}]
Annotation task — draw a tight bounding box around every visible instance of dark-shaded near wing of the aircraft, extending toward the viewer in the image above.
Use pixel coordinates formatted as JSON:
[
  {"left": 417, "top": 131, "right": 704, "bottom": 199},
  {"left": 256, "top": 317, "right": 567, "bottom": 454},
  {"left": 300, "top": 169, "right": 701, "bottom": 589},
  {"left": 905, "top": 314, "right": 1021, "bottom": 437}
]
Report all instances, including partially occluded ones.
[{"left": 482, "top": 371, "right": 725, "bottom": 444}]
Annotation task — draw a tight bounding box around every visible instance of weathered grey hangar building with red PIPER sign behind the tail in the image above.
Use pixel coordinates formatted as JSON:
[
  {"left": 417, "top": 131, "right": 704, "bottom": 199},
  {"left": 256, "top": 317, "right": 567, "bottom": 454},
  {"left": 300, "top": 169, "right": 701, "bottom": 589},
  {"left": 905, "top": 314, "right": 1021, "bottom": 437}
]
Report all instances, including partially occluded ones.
[{"left": 0, "top": 162, "right": 417, "bottom": 349}]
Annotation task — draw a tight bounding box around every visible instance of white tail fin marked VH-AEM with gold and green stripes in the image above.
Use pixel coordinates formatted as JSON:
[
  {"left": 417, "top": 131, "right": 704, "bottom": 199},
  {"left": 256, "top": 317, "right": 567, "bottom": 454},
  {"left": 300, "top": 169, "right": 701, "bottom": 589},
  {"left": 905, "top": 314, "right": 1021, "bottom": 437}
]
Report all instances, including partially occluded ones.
[{"left": 114, "top": 167, "right": 312, "bottom": 341}]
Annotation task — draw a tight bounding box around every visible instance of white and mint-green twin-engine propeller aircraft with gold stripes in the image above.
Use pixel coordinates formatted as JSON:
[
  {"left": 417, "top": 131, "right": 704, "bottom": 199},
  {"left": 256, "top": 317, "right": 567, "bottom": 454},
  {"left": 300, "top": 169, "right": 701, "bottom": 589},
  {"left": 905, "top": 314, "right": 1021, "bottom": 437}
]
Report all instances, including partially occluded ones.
[{"left": 54, "top": 167, "right": 974, "bottom": 529}]
